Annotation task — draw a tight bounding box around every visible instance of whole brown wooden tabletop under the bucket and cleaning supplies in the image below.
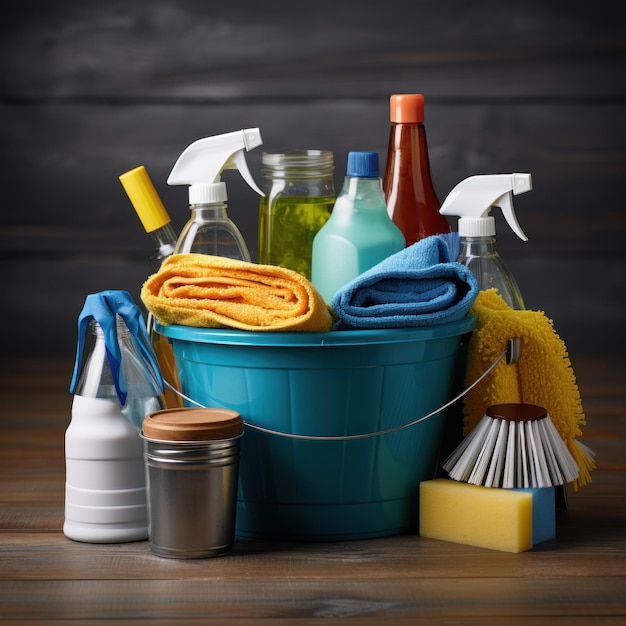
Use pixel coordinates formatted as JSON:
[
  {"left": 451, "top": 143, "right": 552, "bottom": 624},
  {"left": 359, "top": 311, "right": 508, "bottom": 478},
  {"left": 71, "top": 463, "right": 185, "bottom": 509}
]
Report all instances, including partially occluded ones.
[{"left": 0, "top": 355, "right": 626, "bottom": 626}]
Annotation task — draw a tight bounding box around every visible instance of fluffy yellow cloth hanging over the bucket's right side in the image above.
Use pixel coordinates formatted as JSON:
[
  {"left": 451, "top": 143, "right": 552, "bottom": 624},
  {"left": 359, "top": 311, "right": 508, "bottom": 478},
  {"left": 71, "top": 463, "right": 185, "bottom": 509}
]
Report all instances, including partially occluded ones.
[{"left": 463, "top": 289, "right": 595, "bottom": 489}]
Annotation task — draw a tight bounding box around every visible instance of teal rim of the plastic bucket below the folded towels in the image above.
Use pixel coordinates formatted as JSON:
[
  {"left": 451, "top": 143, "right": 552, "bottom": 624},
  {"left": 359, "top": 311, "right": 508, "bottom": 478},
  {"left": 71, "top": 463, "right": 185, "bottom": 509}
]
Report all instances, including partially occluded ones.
[{"left": 154, "top": 313, "right": 476, "bottom": 348}]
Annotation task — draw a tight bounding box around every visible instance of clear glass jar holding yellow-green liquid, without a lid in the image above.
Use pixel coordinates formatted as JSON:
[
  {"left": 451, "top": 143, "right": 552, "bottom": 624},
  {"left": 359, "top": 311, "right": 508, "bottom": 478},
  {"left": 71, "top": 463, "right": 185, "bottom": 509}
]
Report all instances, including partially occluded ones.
[{"left": 258, "top": 150, "right": 335, "bottom": 280}]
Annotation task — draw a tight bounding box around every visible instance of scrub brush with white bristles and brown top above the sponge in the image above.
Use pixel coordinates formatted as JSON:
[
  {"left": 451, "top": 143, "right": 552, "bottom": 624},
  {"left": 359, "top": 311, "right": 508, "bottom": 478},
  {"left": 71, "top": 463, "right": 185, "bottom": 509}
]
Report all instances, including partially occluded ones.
[{"left": 442, "top": 404, "right": 579, "bottom": 488}]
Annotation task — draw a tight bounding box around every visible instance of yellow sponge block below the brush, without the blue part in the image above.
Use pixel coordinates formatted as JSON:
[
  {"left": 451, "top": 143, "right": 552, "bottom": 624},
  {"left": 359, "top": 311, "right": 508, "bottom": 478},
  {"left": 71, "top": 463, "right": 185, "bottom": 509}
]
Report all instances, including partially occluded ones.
[{"left": 419, "top": 478, "right": 533, "bottom": 552}]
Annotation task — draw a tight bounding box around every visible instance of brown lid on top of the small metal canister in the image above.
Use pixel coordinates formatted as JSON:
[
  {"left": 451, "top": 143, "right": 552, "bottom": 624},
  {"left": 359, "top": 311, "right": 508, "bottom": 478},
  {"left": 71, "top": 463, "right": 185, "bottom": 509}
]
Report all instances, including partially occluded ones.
[{"left": 142, "top": 408, "right": 243, "bottom": 441}]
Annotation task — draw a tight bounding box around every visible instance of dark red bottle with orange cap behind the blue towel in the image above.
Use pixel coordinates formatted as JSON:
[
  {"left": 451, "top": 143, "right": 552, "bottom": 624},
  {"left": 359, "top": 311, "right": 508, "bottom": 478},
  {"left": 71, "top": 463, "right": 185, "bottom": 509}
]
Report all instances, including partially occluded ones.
[{"left": 383, "top": 94, "right": 450, "bottom": 246}]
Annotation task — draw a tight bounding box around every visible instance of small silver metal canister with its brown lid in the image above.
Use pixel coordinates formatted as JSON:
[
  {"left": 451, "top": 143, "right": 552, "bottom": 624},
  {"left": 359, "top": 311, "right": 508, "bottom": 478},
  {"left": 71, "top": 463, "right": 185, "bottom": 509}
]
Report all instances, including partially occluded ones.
[{"left": 142, "top": 408, "right": 243, "bottom": 559}]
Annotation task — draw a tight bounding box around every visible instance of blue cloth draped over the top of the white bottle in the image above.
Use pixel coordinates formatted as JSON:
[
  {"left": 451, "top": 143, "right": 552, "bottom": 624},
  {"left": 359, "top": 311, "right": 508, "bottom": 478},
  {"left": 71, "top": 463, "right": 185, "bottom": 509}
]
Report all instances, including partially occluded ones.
[{"left": 70, "top": 289, "right": 164, "bottom": 406}]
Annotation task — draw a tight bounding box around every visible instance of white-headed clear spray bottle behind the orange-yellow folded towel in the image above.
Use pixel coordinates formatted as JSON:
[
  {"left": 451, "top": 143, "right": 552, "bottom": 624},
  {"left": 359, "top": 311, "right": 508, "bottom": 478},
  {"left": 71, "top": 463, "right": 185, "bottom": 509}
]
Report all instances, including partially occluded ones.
[{"left": 167, "top": 128, "right": 265, "bottom": 261}]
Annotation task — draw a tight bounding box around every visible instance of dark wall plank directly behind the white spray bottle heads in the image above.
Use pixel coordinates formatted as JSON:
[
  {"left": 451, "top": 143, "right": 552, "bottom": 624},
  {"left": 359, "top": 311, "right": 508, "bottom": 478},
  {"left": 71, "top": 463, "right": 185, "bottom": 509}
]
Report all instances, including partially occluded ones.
[{"left": 0, "top": 102, "right": 626, "bottom": 258}]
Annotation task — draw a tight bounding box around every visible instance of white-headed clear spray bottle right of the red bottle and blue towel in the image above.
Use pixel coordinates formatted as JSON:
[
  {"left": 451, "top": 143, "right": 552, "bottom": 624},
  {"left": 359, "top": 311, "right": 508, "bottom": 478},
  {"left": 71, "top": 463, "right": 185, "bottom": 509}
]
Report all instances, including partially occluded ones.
[{"left": 439, "top": 174, "right": 532, "bottom": 310}]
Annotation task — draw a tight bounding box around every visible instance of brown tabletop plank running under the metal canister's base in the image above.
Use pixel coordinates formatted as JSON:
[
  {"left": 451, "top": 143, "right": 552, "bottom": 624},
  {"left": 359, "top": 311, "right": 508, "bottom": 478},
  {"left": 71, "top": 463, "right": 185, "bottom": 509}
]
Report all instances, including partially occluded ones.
[{"left": 0, "top": 526, "right": 626, "bottom": 581}]
